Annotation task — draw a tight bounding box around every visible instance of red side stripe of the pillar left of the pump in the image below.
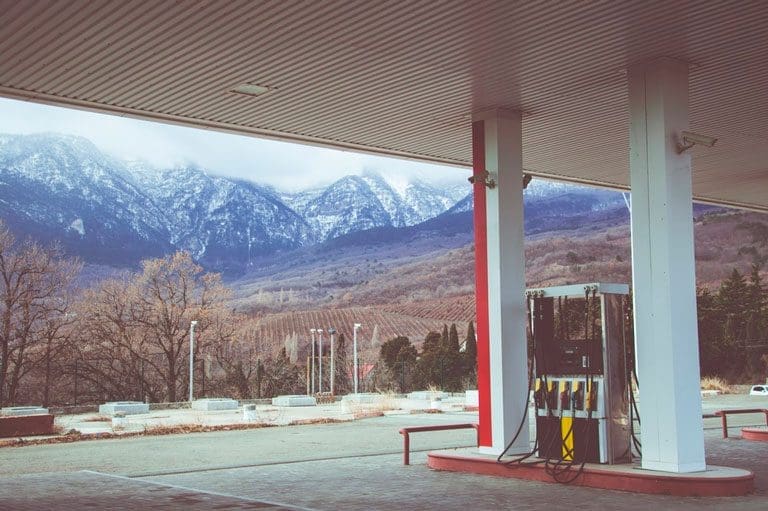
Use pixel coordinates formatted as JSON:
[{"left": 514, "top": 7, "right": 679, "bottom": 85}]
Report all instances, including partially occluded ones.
[{"left": 472, "top": 121, "right": 492, "bottom": 447}]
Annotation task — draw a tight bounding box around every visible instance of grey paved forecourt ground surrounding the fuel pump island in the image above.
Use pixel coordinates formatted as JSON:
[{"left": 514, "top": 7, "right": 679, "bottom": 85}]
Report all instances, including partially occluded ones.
[{"left": 0, "top": 406, "right": 768, "bottom": 511}]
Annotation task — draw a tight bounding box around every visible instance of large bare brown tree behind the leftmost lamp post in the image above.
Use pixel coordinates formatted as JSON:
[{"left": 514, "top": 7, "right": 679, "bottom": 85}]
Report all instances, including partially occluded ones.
[{"left": 80, "top": 252, "right": 233, "bottom": 401}]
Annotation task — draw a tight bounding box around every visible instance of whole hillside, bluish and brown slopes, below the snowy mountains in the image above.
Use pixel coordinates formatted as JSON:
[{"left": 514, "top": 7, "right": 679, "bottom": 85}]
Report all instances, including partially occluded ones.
[{"left": 233, "top": 211, "right": 768, "bottom": 322}]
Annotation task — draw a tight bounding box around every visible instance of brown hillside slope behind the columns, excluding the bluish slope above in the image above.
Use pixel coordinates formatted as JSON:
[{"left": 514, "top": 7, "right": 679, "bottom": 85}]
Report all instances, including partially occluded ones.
[{"left": 332, "top": 212, "right": 768, "bottom": 310}]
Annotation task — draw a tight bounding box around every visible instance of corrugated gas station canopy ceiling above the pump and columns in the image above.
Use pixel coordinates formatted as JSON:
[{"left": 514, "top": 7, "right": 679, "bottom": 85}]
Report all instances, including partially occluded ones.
[{"left": 0, "top": 0, "right": 768, "bottom": 211}]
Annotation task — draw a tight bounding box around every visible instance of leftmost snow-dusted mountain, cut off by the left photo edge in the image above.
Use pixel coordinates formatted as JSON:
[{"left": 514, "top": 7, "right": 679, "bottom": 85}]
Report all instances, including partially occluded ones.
[{"left": 0, "top": 135, "right": 171, "bottom": 263}]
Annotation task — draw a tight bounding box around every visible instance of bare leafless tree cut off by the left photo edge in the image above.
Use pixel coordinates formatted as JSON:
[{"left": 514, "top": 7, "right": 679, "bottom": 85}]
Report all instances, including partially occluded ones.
[{"left": 0, "top": 222, "right": 80, "bottom": 405}]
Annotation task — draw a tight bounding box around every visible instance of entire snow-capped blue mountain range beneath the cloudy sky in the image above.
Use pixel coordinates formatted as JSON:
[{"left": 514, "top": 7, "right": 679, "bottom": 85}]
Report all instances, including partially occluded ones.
[{"left": 0, "top": 134, "right": 468, "bottom": 271}]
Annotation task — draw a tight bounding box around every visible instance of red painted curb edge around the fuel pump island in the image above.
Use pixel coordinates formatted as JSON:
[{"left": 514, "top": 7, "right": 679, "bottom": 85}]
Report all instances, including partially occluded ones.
[{"left": 427, "top": 452, "right": 755, "bottom": 497}]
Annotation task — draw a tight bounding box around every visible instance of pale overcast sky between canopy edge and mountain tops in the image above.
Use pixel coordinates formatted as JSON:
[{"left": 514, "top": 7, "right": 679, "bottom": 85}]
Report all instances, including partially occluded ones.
[{"left": 0, "top": 98, "right": 469, "bottom": 191}]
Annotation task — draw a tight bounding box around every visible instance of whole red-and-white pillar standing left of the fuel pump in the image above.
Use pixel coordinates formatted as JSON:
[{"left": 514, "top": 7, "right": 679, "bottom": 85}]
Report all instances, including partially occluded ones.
[{"left": 473, "top": 109, "right": 530, "bottom": 454}]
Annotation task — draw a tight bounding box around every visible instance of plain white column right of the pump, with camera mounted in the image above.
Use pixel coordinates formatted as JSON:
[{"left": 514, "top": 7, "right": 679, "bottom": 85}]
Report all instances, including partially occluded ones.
[{"left": 628, "top": 58, "right": 706, "bottom": 472}]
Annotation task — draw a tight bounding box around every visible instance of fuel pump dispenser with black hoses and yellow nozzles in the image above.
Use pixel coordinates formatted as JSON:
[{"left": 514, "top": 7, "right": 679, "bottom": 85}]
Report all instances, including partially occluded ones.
[{"left": 526, "top": 283, "right": 631, "bottom": 464}]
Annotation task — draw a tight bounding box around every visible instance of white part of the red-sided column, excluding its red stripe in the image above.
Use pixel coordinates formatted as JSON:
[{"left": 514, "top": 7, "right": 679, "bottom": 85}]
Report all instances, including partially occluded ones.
[{"left": 474, "top": 110, "right": 530, "bottom": 454}]
